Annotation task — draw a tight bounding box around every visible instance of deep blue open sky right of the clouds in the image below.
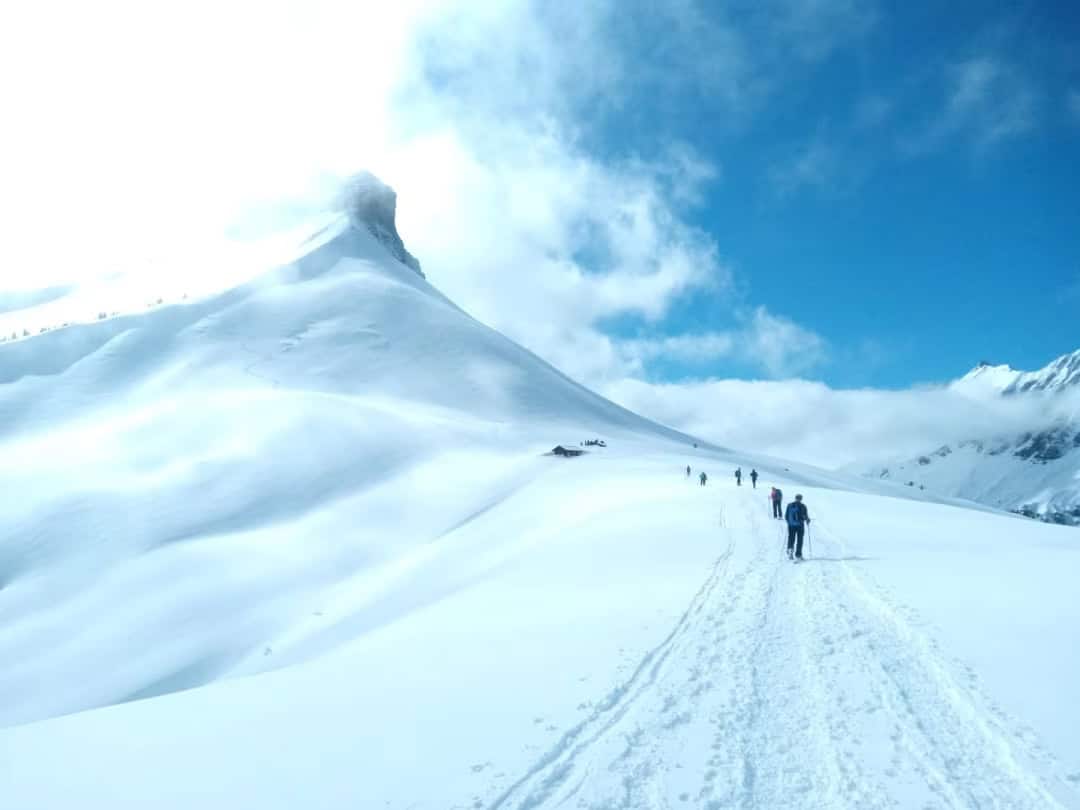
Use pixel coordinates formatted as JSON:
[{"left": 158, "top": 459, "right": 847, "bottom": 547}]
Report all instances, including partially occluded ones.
[{"left": 594, "top": 0, "right": 1080, "bottom": 388}]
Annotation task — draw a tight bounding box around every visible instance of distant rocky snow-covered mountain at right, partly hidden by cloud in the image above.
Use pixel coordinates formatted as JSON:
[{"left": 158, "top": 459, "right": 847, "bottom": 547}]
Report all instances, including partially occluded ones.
[{"left": 867, "top": 351, "right": 1080, "bottom": 525}]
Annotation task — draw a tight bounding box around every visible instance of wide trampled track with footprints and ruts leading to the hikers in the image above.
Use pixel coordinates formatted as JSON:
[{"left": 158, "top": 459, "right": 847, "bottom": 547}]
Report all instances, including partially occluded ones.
[{"left": 483, "top": 499, "right": 1080, "bottom": 810}]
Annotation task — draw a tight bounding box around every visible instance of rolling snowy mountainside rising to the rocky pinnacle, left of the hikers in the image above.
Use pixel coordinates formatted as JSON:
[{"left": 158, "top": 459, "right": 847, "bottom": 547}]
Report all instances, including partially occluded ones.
[{"left": 0, "top": 180, "right": 688, "bottom": 734}]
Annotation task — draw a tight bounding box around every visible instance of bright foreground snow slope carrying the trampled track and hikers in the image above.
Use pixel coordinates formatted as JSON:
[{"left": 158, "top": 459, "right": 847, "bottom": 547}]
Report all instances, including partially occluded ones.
[{"left": 0, "top": 473, "right": 1080, "bottom": 809}]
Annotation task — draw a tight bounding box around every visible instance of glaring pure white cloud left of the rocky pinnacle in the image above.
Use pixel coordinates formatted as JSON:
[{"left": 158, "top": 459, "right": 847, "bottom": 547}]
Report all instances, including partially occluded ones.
[{"left": 0, "top": 0, "right": 429, "bottom": 287}]
